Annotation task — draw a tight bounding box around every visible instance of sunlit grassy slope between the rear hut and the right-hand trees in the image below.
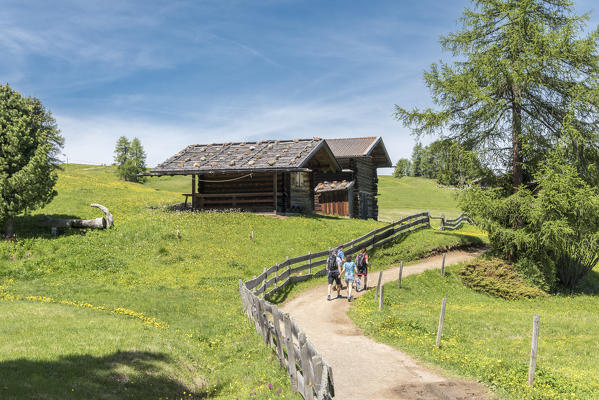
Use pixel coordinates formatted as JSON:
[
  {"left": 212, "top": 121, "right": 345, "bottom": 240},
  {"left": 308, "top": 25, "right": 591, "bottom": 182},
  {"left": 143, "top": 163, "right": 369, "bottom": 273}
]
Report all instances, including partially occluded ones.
[{"left": 378, "top": 176, "right": 461, "bottom": 221}]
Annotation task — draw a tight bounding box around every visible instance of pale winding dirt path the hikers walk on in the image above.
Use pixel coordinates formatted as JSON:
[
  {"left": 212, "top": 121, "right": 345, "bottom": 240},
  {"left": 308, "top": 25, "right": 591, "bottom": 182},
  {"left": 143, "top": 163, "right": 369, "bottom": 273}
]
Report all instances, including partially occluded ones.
[{"left": 282, "top": 250, "right": 491, "bottom": 400}]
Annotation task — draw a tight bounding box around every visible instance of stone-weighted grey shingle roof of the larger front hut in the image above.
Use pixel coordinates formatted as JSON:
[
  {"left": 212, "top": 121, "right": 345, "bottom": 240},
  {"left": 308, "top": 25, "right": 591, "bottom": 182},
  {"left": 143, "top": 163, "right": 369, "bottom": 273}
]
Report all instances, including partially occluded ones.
[{"left": 148, "top": 138, "right": 341, "bottom": 175}]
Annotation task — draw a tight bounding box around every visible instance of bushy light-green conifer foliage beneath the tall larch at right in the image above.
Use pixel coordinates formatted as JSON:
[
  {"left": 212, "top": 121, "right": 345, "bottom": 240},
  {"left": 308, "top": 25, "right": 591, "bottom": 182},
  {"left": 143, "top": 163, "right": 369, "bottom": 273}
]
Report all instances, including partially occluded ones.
[{"left": 460, "top": 152, "right": 599, "bottom": 289}]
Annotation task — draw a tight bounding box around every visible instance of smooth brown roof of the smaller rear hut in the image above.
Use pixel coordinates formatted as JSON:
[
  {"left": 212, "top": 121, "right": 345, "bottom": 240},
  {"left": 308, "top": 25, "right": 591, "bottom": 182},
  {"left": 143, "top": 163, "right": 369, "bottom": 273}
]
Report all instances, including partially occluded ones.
[{"left": 326, "top": 136, "right": 393, "bottom": 168}]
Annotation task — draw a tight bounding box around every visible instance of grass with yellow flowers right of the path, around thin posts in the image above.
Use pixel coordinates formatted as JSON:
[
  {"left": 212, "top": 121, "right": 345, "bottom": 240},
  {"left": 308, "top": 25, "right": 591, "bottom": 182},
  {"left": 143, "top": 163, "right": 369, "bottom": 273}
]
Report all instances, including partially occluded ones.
[{"left": 350, "top": 267, "right": 599, "bottom": 399}]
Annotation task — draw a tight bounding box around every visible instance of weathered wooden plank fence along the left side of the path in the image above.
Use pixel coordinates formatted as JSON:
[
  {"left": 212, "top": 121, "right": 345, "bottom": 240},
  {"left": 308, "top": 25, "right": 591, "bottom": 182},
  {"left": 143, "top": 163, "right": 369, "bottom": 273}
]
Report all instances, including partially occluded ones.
[{"left": 239, "top": 212, "right": 469, "bottom": 400}]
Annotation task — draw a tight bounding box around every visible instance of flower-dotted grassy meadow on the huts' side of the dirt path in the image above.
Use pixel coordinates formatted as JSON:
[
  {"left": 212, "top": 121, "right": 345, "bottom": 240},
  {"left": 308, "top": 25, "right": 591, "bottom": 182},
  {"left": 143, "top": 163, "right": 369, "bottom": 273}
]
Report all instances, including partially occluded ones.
[{"left": 0, "top": 165, "right": 481, "bottom": 399}]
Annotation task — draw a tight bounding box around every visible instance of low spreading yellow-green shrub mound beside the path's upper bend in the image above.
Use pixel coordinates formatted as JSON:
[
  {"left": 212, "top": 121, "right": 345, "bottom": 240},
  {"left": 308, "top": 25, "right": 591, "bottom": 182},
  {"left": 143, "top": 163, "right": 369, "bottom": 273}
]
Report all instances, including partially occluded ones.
[{"left": 458, "top": 258, "right": 545, "bottom": 300}]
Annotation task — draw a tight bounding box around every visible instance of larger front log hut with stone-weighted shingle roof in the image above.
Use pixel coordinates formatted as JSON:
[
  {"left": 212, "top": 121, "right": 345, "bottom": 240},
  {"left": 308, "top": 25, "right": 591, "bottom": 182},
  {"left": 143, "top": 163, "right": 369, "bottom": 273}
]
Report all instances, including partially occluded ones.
[{"left": 148, "top": 138, "right": 341, "bottom": 214}]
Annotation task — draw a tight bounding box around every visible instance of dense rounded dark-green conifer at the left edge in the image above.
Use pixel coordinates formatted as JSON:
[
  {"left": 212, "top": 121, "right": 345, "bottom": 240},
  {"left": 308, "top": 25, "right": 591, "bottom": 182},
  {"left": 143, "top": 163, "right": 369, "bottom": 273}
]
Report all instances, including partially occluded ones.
[{"left": 0, "top": 84, "right": 63, "bottom": 235}]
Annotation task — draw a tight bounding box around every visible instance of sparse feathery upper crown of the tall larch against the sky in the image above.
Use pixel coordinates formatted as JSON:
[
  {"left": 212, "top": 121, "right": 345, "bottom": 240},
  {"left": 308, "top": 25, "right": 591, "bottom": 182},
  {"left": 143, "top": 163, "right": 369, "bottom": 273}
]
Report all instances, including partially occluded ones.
[{"left": 395, "top": 0, "right": 599, "bottom": 188}]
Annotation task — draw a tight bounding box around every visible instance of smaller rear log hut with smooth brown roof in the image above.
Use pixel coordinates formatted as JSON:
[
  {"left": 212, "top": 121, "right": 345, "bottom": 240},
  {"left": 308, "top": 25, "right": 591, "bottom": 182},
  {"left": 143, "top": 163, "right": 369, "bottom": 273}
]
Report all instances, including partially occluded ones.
[{"left": 314, "top": 137, "right": 393, "bottom": 219}]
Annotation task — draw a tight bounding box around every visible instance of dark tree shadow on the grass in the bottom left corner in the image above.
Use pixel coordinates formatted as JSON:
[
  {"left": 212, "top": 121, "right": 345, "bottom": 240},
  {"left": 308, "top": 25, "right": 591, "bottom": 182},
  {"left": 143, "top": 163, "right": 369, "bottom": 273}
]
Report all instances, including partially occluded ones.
[{"left": 0, "top": 351, "right": 224, "bottom": 399}]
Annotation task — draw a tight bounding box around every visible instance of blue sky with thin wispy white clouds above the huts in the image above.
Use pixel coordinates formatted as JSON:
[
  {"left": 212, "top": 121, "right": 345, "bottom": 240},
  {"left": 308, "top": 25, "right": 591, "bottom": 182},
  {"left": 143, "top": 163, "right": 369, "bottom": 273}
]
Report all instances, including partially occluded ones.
[{"left": 0, "top": 0, "right": 599, "bottom": 172}]
